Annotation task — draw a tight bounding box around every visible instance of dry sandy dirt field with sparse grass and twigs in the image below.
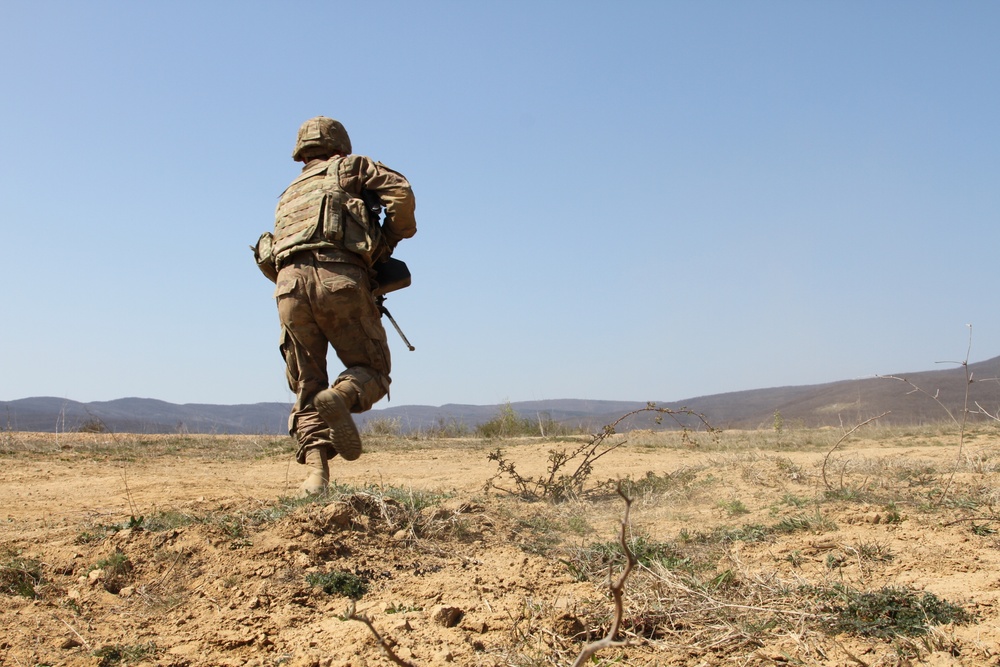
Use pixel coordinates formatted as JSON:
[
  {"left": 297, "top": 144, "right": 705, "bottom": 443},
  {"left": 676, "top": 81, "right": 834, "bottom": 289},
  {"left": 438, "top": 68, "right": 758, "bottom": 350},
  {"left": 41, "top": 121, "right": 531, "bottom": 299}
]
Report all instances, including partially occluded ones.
[{"left": 0, "top": 426, "right": 1000, "bottom": 667}]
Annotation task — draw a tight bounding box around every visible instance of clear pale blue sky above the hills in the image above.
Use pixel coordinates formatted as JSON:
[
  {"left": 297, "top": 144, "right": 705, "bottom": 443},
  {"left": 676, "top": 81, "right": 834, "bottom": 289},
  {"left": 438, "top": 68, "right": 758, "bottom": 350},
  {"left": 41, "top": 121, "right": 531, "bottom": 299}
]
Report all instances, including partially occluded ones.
[{"left": 0, "top": 0, "right": 1000, "bottom": 407}]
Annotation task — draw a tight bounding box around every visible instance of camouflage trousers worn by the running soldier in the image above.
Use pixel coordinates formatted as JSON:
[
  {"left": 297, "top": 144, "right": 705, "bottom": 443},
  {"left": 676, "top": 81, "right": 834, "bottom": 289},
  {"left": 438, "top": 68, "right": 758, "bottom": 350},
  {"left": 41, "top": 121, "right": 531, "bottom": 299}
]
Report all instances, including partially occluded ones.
[{"left": 274, "top": 251, "right": 390, "bottom": 459}]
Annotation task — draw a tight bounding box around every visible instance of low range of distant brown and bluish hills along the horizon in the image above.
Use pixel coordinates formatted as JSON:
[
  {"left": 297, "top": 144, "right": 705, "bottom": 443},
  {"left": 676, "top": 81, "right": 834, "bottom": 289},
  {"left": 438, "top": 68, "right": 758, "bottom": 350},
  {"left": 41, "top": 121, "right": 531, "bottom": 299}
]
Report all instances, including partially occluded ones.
[{"left": 0, "top": 357, "right": 1000, "bottom": 434}]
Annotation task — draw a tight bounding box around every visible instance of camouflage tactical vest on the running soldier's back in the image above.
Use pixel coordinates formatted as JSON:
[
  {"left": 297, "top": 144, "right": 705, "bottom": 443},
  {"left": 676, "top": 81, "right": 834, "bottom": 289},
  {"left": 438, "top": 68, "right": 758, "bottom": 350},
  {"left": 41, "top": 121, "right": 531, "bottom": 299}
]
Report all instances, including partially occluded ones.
[{"left": 274, "top": 158, "right": 381, "bottom": 267}]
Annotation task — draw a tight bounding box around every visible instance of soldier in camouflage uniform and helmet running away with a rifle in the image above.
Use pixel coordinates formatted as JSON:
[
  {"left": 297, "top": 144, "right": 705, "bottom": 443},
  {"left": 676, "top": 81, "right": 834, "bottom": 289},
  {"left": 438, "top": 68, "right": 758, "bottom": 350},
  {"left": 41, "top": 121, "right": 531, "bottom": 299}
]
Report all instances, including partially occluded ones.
[{"left": 255, "top": 116, "right": 417, "bottom": 494}]
